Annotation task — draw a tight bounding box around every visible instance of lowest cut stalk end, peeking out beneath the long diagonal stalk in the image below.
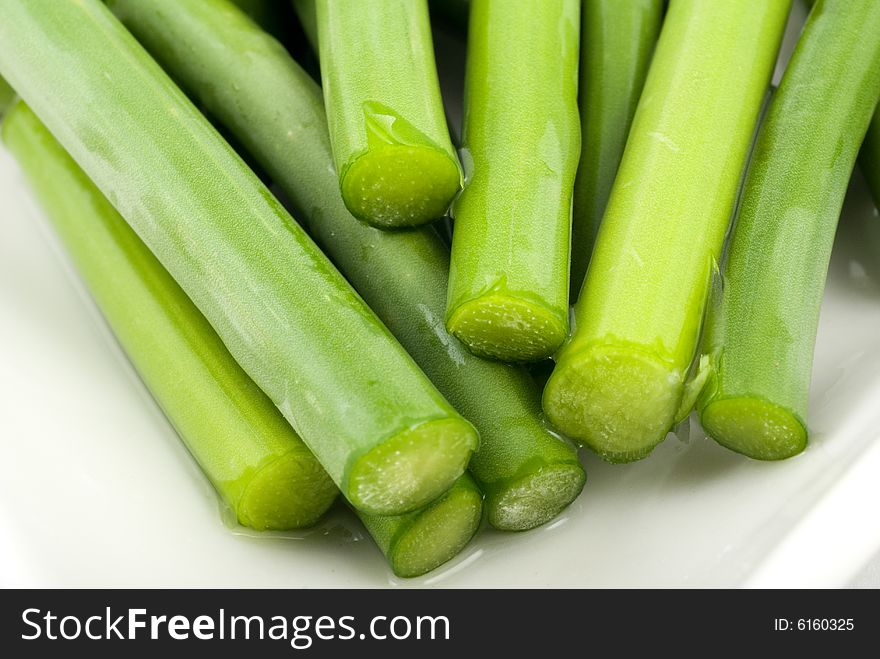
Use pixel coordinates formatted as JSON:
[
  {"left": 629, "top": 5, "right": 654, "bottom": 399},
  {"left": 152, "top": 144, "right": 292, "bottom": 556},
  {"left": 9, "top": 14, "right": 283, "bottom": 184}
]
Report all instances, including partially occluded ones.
[{"left": 358, "top": 474, "right": 483, "bottom": 577}]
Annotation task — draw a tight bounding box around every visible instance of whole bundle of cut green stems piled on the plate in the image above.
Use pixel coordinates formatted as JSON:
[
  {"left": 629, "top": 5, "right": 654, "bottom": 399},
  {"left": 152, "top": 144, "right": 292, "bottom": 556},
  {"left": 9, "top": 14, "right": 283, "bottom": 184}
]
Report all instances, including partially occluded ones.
[{"left": 0, "top": 0, "right": 868, "bottom": 576}]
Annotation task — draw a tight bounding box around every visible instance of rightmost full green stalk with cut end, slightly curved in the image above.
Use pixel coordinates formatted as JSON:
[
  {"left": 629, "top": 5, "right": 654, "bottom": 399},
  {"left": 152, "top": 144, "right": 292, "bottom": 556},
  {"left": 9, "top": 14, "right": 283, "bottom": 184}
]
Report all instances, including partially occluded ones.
[{"left": 700, "top": 0, "right": 880, "bottom": 460}]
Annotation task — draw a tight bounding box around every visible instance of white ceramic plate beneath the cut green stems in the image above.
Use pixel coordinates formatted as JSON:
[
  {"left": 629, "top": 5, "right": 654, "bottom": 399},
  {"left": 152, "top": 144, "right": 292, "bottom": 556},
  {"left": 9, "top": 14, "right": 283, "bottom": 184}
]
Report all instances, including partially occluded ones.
[{"left": 0, "top": 1, "right": 880, "bottom": 587}]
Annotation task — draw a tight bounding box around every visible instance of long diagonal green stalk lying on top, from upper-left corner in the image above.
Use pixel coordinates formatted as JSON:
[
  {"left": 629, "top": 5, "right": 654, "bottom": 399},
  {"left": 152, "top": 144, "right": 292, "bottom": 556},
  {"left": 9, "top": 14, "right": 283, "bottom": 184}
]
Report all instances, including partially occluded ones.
[{"left": 0, "top": 0, "right": 477, "bottom": 514}]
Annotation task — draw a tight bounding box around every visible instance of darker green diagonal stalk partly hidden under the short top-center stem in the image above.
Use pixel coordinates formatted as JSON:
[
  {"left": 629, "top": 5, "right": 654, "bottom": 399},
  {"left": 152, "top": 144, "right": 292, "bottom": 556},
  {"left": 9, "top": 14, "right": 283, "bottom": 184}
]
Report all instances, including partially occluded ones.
[{"left": 115, "top": 0, "right": 584, "bottom": 530}]
